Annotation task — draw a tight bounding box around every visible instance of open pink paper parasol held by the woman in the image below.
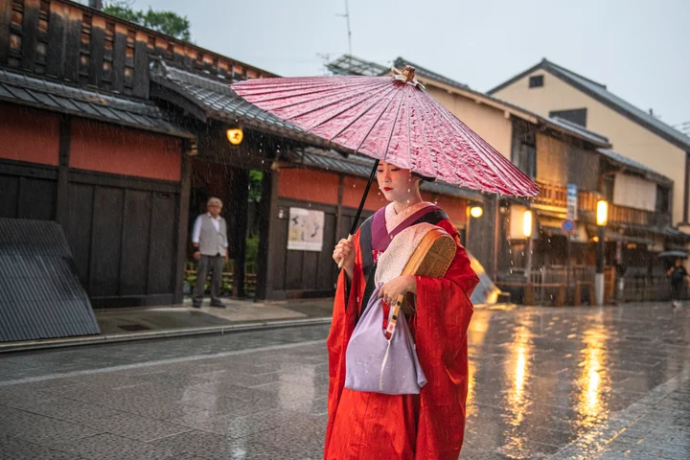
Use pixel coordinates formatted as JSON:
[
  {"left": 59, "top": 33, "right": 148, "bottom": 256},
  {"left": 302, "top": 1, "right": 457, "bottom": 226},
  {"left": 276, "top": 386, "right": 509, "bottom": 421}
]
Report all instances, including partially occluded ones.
[{"left": 232, "top": 66, "right": 539, "bottom": 241}]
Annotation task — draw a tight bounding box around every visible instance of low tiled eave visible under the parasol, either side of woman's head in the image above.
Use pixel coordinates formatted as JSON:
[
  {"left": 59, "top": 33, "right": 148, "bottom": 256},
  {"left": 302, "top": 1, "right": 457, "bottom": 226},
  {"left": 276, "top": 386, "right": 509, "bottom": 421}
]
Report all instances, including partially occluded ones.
[{"left": 295, "top": 148, "right": 483, "bottom": 201}]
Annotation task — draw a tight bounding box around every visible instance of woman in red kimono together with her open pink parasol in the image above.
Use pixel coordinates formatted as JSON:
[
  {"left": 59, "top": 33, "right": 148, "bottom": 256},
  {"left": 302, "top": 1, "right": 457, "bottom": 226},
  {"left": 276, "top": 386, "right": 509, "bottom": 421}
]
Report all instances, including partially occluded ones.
[{"left": 231, "top": 66, "right": 539, "bottom": 460}]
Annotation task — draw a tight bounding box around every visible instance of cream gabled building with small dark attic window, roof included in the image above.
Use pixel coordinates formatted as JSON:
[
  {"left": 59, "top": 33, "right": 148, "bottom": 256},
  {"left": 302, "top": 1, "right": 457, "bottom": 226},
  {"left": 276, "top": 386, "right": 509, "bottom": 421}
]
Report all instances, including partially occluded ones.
[{"left": 489, "top": 59, "right": 690, "bottom": 234}]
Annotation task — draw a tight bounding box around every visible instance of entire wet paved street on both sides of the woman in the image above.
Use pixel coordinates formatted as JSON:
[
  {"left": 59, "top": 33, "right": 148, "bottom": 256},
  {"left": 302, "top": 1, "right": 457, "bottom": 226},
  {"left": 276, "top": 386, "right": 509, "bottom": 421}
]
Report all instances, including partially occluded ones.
[{"left": 0, "top": 305, "right": 690, "bottom": 460}]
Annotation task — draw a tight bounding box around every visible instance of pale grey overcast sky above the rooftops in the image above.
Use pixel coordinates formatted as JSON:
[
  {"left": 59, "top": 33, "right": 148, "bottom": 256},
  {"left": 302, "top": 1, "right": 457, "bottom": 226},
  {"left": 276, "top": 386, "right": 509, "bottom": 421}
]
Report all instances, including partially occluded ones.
[{"left": 115, "top": 0, "right": 690, "bottom": 125}]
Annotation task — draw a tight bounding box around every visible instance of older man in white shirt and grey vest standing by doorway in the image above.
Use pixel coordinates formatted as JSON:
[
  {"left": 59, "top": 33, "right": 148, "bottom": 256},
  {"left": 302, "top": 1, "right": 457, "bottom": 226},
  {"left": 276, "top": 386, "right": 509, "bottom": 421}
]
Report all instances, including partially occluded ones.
[{"left": 192, "top": 198, "right": 228, "bottom": 308}]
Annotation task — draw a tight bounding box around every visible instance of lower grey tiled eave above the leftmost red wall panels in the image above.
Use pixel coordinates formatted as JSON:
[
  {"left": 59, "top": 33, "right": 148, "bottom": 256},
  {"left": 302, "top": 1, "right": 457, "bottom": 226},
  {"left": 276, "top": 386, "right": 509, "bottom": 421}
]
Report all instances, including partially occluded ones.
[{"left": 0, "top": 68, "right": 192, "bottom": 137}]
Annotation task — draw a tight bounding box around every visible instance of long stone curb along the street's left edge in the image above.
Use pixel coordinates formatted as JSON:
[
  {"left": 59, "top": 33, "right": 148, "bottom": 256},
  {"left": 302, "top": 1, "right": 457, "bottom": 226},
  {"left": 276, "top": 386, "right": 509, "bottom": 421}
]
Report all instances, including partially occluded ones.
[{"left": 0, "top": 317, "right": 331, "bottom": 354}]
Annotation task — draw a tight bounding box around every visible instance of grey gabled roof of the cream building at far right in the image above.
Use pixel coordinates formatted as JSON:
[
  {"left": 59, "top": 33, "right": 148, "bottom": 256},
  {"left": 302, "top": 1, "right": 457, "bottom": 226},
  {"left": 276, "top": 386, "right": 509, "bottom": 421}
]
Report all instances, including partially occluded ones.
[{"left": 488, "top": 59, "right": 690, "bottom": 150}]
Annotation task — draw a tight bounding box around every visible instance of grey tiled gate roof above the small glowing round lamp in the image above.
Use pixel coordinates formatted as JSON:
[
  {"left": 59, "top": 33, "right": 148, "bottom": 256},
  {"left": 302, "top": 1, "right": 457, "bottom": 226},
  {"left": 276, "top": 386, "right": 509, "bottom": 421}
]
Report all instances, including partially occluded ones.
[{"left": 151, "top": 61, "right": 344, "bottom": 147}]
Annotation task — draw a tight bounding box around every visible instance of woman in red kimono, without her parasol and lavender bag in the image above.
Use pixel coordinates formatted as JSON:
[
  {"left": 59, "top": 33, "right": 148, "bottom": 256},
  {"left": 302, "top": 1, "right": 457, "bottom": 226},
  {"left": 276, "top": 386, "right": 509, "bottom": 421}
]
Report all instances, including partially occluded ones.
[{"left": 325, "top": 162, "right": 479, "bottom": 460}]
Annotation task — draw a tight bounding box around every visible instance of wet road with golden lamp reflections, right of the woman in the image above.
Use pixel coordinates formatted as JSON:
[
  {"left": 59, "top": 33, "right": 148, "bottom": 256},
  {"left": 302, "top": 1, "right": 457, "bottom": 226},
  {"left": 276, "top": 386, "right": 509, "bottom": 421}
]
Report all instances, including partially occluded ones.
[{"left": 463, "top": 306, "right": 690, "bottom": 459}]
